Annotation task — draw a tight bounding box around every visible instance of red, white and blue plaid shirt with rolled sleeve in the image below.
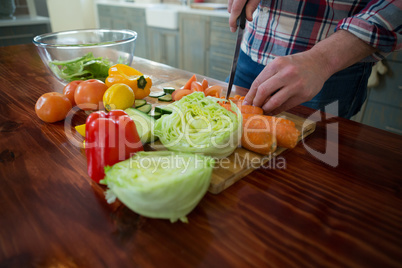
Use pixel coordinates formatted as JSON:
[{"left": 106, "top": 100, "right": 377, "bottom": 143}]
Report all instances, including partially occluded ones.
[{"left": 241, "top": 0, "right": 402, "bottom": 65}]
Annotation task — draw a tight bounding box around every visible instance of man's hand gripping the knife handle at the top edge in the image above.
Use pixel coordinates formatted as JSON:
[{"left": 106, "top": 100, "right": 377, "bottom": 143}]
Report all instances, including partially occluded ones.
[{"left": 228, "top": 0, "right": 260, "bottom": 32}]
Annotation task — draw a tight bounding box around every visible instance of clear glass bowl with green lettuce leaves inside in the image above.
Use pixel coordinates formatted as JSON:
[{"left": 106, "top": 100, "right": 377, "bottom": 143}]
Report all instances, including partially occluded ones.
[{"left": 33, "top": 29, "right": 137, "bottom": 84}]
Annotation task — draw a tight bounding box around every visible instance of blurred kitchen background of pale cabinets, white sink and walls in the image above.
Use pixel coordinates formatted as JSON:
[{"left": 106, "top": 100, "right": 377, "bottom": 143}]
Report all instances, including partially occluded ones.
[{"left": 0, "top": 0, "right": 402, "bottom": 134}]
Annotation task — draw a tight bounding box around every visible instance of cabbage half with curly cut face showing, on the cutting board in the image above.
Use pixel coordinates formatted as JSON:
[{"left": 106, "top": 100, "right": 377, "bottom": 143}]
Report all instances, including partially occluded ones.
[{"left": 154, "top": 92, "right": 242, "bottom": 158}]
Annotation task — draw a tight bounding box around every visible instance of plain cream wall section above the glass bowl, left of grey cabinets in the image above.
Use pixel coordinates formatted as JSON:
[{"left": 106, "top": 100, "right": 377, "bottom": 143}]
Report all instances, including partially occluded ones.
[{"left": 46, "top": 0, "right": 96, "bottom": 32}]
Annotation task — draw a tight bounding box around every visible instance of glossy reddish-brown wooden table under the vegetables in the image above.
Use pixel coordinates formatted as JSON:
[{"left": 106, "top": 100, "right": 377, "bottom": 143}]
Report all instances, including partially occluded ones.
[{"left": 0, "top": 45, "right": 402, "bottom": 267}]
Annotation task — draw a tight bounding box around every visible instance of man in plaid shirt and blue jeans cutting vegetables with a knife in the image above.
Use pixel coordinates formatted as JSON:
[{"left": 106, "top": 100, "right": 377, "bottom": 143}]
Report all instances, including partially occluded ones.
[{"left": 228, "top": 0, "right": 402, "bottom": 118}]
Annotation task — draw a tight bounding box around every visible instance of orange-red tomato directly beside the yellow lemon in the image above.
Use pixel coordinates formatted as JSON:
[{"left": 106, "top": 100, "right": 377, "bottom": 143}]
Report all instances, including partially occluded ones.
[{"left": 74, "top": 79, "right": 107, "bottom": 110}]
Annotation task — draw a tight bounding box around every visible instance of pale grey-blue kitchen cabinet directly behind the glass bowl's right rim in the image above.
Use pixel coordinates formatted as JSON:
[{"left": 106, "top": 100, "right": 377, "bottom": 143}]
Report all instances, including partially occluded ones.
[{"left": 97, "top": 4, "right": 148, "bottom": 58}]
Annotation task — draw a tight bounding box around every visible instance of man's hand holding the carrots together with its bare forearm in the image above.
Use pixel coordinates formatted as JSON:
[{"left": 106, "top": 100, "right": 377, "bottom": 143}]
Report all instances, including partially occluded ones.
[{"left": 243, "top": 30, "right": 376, "bottom": 114}]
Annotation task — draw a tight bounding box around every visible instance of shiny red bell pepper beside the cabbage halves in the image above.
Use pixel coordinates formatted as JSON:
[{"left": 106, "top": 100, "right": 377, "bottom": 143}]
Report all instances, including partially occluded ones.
[{"left": 85, "top": 110, "right": 144, "bottom": 183}]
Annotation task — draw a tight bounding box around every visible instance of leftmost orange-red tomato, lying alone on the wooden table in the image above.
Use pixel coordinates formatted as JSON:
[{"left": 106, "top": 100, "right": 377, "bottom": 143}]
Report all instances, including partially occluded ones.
[{"left": 35, "top": 92, "right": 72, "bottom": 123}]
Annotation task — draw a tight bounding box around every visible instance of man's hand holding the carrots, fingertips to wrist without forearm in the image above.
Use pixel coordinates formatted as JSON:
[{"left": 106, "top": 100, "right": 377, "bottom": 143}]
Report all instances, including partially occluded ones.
[{"left": 245, "top": 52, "right": 330, "bottom": 114}]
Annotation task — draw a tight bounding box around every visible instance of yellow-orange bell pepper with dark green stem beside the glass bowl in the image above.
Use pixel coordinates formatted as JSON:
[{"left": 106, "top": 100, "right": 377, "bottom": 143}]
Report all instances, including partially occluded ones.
[{"left": 105, "top": 64, "right": 152, "bottom": 99}]
